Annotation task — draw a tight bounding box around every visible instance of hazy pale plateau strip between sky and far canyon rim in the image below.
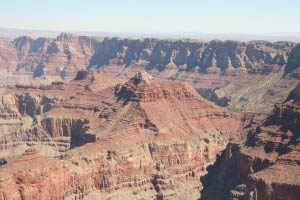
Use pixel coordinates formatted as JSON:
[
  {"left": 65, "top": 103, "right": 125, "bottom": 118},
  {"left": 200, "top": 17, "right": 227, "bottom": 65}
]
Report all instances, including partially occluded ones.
[{"left": 0, "top": 27, "right": 300, "bottom": 43}]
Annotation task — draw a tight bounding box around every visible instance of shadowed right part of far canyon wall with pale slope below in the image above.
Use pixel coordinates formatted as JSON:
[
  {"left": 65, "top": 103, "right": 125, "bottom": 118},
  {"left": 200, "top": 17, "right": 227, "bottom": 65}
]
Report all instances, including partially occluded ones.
[{"left": 90, "top": 38, "right": 299, "bottom": 113}]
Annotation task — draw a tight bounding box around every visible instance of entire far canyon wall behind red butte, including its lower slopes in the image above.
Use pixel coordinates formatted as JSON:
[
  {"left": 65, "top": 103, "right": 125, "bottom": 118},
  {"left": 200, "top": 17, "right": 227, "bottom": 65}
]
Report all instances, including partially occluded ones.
[{"left": 0, "top": 33, "right": 299, "bottom": 113}]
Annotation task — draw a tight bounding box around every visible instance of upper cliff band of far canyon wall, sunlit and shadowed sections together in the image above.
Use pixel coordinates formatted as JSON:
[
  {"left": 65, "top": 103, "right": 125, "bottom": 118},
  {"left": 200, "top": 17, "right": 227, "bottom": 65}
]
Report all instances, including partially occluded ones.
[{"left": 0, "top": 33, "right": 296, "bottom": 79}]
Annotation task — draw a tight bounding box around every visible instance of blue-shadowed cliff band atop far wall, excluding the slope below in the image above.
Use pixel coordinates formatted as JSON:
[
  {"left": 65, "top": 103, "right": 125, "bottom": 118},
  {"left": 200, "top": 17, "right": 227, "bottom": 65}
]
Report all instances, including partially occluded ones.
[{"left": 90, "top": 38, "right": 294, "bottom": 73}]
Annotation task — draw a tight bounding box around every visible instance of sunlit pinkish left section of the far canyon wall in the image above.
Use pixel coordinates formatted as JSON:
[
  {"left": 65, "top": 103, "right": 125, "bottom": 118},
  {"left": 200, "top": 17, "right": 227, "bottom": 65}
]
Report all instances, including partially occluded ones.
[{"left": 3, "top": 33, "right": 97, "bottom": 79}]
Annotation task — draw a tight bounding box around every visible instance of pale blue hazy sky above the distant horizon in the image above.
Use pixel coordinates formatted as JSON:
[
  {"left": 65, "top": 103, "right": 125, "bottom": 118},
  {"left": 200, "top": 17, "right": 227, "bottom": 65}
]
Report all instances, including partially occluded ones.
[{"left": 0, "top": 0, "right": 300, "bottom": 34}]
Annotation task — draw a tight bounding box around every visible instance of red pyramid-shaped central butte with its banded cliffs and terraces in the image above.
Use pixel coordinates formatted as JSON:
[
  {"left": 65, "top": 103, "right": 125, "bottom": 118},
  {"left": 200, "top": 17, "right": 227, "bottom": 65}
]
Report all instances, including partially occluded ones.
[{"left": 0, "top": 71, "right": 256, "bottom": 199}]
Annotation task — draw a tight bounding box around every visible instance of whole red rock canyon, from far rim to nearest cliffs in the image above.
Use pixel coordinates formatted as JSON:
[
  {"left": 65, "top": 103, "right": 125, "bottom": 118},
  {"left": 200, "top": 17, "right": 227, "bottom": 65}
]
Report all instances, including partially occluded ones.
[{"left": 0, "top": 33, "right": 300, "bottom": 200}]
